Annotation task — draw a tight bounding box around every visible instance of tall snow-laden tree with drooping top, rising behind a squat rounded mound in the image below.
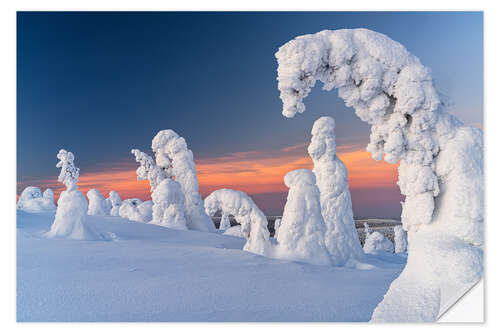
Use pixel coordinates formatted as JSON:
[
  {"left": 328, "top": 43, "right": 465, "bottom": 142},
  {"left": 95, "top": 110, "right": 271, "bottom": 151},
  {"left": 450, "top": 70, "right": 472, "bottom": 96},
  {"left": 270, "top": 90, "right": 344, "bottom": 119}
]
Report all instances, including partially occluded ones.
[{"left": 151, "top": 130, "right": 215, "bottom": 232}]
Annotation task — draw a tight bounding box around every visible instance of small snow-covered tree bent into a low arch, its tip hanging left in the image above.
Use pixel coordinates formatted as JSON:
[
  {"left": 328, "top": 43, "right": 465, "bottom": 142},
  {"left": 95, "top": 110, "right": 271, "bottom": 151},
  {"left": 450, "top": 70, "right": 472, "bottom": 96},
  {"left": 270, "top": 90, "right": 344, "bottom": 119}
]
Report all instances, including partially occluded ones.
[{"left": 205, "top": 189, "right": 271, "bottom": 256}]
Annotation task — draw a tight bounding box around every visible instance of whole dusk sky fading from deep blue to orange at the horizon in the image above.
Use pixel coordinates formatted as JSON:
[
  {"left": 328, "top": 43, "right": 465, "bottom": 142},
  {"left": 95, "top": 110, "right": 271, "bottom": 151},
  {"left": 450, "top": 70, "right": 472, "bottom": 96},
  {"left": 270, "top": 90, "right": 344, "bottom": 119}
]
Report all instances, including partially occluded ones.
[{"left": 17, "top": 12, "right": 483, "bottom": 217}]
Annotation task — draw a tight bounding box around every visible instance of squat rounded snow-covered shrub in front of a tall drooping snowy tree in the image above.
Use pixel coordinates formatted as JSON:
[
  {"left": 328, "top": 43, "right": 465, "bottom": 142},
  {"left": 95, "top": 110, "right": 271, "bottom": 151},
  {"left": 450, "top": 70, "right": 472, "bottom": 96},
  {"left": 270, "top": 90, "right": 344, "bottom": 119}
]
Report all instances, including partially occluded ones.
[{"left": 151, "top": 179, "right": 187, "bottom": 230}]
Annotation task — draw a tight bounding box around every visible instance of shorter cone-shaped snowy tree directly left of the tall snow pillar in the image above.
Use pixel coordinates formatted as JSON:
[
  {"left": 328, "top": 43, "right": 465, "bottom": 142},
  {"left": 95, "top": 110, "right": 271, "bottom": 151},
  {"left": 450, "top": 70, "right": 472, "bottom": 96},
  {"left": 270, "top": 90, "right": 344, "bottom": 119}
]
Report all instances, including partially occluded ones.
[{"left": 275, "top": 169, "right": 331, "bottom": 265}]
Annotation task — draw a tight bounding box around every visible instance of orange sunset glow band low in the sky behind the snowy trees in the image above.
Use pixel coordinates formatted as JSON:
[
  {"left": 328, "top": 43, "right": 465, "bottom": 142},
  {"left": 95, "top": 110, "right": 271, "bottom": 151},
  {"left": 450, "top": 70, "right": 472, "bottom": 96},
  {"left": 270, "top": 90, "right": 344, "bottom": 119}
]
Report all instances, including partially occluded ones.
[{"left": 18, "top": 145, "right": 397, "bottom": 200}]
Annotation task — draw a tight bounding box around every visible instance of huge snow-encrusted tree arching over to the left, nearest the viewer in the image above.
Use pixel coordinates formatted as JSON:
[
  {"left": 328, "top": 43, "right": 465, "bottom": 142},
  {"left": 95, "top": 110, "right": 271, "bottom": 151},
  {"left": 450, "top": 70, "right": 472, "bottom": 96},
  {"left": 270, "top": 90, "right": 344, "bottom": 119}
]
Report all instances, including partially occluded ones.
[{"left": 276, "top": 29, "right": 484, "bottom": 321}]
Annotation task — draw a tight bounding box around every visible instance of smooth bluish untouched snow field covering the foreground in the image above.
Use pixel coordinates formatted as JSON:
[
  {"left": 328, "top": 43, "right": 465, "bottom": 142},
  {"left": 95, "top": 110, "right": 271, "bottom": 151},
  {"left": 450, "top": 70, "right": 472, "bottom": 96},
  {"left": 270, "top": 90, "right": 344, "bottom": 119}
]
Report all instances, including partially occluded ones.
[{"left": 17, "top": 211, "right": 406, "bottom": 321}]
